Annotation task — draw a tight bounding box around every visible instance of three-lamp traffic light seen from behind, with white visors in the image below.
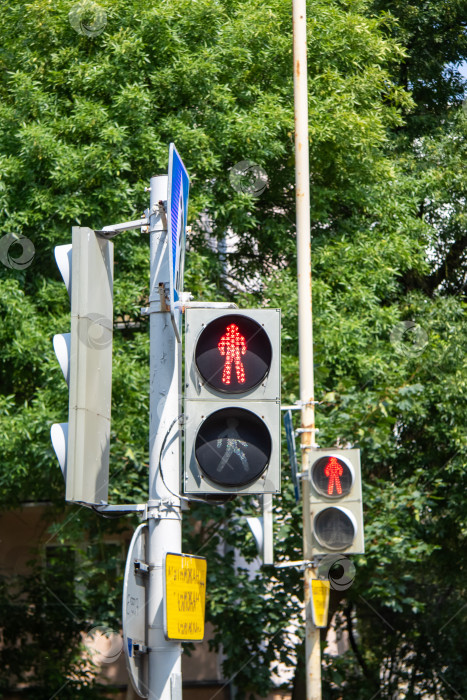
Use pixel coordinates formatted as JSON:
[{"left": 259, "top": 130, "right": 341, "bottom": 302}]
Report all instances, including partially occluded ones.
[{"left": 51, "top": 226, "right": 113, "bottom": 504}]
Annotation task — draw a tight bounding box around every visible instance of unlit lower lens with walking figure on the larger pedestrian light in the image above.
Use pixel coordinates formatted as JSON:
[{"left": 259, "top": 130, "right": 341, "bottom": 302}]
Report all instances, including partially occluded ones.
[{"left": 195, "top": 408, "right": 272, "bottom": 487}]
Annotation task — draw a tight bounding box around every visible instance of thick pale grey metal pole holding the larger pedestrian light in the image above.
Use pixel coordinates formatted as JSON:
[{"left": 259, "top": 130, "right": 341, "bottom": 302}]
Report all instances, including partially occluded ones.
[{"left": 147, "top": 175, "right": 182, "bottom": 700}]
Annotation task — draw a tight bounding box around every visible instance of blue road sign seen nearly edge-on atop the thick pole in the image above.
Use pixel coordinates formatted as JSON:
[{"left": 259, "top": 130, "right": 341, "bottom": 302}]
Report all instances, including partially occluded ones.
[{"left": 167, "top": 143, "right": 190, "bottom": 342}]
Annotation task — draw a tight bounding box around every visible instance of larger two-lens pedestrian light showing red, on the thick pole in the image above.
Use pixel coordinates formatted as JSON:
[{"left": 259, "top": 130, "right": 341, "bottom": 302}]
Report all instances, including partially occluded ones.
[{"left": 183, "top": 309, "right": 280, "bottom": 496}]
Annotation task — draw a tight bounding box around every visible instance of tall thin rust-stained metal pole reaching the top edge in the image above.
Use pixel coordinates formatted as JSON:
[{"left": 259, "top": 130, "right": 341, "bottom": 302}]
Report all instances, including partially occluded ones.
[{"left": 292, "top": 0, "right": 321, "bottom": 700}]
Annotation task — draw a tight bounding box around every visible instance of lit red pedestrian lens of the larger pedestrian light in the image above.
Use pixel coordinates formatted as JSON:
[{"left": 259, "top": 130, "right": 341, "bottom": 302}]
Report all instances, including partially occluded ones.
[{"left": 195, "top": 314, "right": 272, "bottom": 394}]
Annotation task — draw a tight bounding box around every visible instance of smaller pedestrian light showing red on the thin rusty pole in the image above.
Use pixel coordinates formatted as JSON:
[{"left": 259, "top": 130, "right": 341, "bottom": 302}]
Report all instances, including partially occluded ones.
[{"left": 309, "top": 448, "right": 365, "bottom": 554}]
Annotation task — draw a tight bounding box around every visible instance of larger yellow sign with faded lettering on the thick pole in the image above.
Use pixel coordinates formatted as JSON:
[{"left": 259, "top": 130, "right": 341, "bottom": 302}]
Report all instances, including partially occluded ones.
[{"left": 165, "top": 554, "right": 206, "bottom": 642}]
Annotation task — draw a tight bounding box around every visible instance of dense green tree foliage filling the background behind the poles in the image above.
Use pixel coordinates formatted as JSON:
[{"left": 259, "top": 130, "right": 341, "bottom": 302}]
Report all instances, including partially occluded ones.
[{"left": 0, "top": 0, "right": 467, "bottom": 700}]
